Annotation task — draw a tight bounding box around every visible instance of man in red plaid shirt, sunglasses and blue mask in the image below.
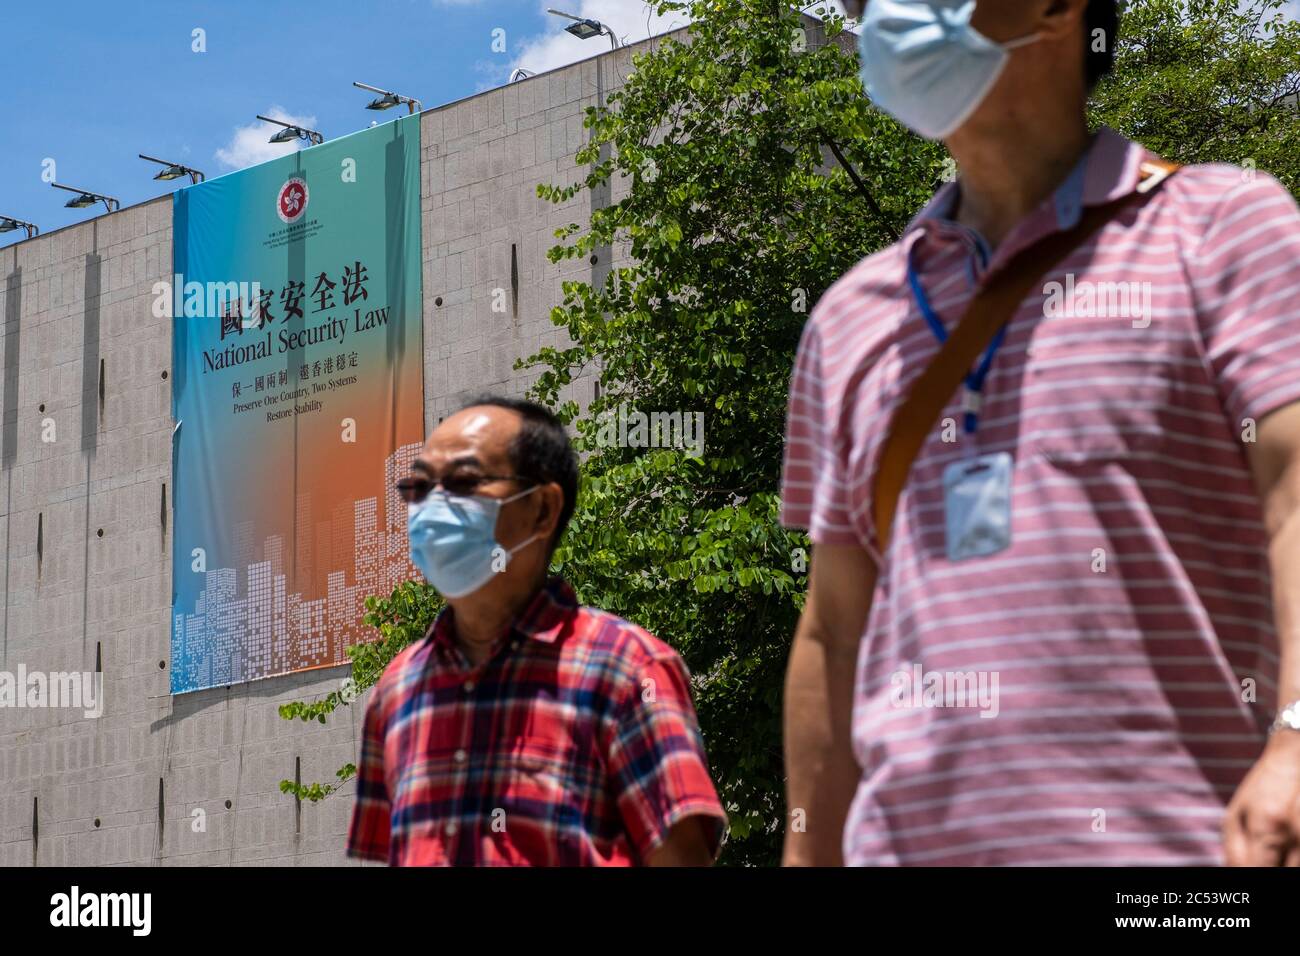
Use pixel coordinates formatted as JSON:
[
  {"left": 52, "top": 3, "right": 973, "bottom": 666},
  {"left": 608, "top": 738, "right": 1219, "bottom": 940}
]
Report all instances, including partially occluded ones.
[{"left": 347, "top": 397, "right": 727, "bottom": 866}]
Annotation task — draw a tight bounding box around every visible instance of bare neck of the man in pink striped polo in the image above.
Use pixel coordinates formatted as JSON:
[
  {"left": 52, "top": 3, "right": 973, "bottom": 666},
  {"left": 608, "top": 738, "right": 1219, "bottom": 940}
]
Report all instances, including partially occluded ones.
[{"left": 948, "top": 113, "right": 1089, "bottom": 247}]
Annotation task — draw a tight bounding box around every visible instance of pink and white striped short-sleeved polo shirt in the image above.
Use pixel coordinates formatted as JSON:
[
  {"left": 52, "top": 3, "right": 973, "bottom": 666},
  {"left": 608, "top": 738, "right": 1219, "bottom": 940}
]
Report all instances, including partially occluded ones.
[{"left": 781, "top": 130, "right": 1300, "bottom": 865}]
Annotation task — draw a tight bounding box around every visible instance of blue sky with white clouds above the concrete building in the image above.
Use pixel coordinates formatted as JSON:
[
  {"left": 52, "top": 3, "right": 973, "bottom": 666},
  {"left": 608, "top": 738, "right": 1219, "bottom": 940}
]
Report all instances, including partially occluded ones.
[{"left": 0, "top": 0, "right": 691, "bottom": 246}]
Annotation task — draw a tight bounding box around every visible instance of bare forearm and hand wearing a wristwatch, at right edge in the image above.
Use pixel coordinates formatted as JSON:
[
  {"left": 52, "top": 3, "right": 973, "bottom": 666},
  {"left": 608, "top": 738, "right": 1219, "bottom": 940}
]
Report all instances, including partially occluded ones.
[{"left": 1223, "top": 402, "right": 1300, "bottom": 866}]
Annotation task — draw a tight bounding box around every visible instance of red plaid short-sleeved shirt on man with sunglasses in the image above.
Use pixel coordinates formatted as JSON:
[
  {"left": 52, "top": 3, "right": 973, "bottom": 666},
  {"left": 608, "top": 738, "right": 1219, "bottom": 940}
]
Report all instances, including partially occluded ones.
[{"left": 347, "top": 579, "right": 727, "bottom": 866}]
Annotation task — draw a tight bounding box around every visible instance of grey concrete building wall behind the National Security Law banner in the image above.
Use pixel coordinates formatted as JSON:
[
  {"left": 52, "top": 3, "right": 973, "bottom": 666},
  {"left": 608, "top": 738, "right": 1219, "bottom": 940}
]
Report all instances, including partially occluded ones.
[{"left": 0, "top": 41, "right": 632, "bottom": 866}]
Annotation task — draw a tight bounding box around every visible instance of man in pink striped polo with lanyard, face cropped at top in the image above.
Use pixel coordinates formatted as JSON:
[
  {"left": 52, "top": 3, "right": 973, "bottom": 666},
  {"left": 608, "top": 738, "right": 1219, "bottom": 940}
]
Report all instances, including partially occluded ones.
[{"left": 783, "top": 0, "right": 1300, "bottom": 866}]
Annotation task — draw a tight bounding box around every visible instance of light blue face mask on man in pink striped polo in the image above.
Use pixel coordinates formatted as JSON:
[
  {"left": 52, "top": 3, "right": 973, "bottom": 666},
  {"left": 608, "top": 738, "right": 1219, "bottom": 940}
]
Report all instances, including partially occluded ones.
[{"left": 858, "top": 0, "right": 1039, "bottom": 139}]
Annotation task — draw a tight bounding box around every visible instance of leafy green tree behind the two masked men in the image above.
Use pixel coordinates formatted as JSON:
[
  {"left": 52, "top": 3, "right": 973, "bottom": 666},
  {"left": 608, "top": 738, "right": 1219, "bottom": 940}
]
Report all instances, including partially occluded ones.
[{"left": 281, "top": 0, "right": 1300, "bottom": 865}]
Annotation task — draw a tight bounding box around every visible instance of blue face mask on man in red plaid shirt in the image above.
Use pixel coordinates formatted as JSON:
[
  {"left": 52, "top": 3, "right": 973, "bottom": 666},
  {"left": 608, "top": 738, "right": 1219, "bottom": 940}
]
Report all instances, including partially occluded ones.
[{"left": 407, "top": 485, "right": 540, "bottom": 597}]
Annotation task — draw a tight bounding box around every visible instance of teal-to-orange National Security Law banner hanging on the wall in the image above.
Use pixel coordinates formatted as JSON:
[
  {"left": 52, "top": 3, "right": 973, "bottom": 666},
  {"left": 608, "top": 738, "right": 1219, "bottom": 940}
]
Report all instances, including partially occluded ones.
[{"left": 172, "top": 116, "right": 424, "bottom": 693}]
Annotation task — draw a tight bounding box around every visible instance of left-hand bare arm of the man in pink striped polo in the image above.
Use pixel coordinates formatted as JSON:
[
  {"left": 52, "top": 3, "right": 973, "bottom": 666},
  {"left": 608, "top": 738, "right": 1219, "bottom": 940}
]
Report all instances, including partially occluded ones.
[{"left": 783, "top": 545, "right": 876, "bottom": 866}]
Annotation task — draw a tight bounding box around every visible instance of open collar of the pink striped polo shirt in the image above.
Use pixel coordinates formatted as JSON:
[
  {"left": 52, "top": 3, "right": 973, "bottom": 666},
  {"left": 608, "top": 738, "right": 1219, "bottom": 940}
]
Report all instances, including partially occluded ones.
[{"left": 904, "top": 126, "right": 1147, "bottom": 258}]
